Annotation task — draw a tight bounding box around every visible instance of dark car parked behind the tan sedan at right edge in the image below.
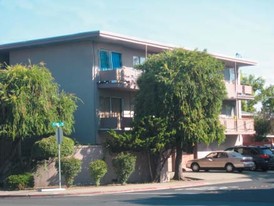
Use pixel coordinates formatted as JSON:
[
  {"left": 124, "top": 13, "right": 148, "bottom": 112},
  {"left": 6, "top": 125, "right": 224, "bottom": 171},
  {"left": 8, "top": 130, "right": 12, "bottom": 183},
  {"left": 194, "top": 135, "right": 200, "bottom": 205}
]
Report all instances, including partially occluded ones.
[{"left": 225, "top": 146, "right": 274, "bottom": 171}]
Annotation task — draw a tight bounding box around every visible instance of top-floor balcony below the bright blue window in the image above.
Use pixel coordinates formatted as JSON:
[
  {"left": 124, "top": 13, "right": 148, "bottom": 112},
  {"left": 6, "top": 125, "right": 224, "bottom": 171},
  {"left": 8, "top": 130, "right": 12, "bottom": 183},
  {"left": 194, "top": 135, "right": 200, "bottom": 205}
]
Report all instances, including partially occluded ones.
[{"left": 97, "top": 67, "right": 141, "bottom": 90}]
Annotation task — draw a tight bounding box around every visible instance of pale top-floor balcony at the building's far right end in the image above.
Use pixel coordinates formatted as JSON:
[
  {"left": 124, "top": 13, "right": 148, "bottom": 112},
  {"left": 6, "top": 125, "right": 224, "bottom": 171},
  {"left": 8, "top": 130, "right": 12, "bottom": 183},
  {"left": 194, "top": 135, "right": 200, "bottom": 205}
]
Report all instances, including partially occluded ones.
[{"left": 225, "top": 82, "right": 254, "bottom": 100}]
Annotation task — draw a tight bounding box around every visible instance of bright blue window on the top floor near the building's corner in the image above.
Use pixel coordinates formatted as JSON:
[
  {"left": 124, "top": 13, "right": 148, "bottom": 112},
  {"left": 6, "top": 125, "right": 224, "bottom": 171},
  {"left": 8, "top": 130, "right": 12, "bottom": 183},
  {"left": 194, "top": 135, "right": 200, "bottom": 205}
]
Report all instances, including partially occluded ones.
[{"left": 99, "top": 50, "right": 122, "bottom": 71}]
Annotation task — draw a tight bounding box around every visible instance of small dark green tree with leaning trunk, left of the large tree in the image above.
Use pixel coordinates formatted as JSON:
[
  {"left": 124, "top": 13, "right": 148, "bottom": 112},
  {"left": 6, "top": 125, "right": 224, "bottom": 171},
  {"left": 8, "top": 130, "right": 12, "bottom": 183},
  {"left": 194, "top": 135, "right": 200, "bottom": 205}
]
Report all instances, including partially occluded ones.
[{"left": 105, "top": 116, "right": 174, "bottom": 182}]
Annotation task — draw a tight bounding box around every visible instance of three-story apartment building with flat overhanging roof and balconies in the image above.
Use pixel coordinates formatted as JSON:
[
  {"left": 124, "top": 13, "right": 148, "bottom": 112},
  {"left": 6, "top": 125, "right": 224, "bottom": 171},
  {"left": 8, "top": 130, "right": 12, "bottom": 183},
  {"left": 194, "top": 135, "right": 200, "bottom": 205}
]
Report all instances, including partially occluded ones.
[{"left": 0, "top": 31, "right": 256, "bottom": 156}]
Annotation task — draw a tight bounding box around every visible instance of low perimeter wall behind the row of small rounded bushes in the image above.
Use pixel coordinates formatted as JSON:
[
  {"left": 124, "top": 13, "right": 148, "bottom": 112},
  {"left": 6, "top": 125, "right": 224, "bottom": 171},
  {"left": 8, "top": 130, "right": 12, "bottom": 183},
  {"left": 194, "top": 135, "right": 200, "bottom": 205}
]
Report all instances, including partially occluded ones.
[{"left": 34, "top": 145, "right": 150, "bottom": 188}]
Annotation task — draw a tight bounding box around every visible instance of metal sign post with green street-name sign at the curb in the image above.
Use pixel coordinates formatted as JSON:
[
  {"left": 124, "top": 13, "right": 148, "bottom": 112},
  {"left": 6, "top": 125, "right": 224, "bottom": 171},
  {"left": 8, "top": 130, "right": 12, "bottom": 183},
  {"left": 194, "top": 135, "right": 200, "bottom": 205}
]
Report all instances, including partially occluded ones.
[{"left": 52, "top": 122, "right": 64, "bottom": 189}]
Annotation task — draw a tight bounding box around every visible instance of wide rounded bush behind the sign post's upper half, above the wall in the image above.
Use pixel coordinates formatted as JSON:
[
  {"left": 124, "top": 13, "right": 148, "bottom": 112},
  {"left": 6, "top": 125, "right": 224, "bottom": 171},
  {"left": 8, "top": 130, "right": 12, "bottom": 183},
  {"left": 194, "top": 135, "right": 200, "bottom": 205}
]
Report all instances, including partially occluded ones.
[{"left": 32, "top": 136, "right": 74, "bottom": 160}]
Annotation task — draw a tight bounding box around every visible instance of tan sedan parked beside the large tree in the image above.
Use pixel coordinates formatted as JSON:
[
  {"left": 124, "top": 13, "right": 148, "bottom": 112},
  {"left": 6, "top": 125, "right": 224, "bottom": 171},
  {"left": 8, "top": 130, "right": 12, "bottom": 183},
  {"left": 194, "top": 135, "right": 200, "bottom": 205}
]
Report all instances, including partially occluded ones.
[{"left": 186, "top": 151, "right": 254, "bottom": 172}]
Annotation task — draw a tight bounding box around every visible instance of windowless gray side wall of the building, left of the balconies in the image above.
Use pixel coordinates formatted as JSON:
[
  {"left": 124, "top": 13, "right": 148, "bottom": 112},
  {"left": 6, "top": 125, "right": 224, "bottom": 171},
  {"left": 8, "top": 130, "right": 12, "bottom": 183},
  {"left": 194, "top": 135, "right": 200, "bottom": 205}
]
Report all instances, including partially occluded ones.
[{"left": 10, "top": 42, "right": 97, "bottom": 144}]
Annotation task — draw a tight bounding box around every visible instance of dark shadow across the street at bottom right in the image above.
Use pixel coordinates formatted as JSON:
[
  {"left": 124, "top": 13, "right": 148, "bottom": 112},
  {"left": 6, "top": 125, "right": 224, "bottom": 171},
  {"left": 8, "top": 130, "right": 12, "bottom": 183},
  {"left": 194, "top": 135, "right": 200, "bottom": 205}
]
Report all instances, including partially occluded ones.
[{"left": 122, "top": 189, "right": 274, "bottom": 206}]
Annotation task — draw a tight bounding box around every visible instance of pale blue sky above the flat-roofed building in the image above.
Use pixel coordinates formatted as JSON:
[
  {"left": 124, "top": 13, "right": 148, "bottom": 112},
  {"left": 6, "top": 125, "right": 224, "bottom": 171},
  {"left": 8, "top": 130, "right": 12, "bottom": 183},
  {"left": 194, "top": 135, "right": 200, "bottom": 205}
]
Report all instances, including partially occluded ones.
[{"left": 0, "top": 0, "right": 274, "bottom": 85}]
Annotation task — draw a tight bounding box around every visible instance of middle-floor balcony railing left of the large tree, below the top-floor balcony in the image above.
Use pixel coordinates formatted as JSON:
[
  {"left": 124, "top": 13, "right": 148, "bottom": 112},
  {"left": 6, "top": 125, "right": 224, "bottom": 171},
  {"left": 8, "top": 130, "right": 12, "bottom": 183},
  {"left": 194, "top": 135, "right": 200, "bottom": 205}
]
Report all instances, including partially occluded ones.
[{"left": 99, "top": 117, "right": 133, "bottom": 130}]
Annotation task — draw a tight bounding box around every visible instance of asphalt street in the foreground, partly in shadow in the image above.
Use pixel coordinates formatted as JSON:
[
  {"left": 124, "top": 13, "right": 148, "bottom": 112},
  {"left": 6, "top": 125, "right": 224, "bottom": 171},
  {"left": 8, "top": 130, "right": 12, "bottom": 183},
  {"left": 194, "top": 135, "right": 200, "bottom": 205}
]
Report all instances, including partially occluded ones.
[{"left": 0, "top": 172, "right": 274, "bottom": 206}]
